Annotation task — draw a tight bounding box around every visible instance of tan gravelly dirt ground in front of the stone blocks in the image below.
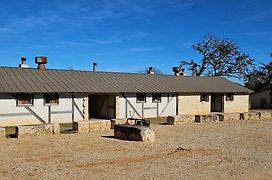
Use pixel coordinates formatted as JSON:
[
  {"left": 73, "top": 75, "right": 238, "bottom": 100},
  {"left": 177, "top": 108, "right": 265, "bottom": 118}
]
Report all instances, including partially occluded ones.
[{"left": 0, "top": 121, "right": 272, "bottom": 179}]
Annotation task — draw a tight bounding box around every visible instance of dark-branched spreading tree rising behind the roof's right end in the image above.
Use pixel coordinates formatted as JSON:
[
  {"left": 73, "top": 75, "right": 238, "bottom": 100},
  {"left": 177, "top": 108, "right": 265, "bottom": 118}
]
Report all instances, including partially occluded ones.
[{"left": 181, "top": 34, "right": 253, "bottom": 79}]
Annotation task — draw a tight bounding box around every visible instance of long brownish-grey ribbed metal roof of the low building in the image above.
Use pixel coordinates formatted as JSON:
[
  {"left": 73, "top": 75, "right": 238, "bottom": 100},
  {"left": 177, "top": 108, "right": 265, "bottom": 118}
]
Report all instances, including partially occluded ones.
[{"left": 0, "top": 67, "right": 253, "bottom": 94}]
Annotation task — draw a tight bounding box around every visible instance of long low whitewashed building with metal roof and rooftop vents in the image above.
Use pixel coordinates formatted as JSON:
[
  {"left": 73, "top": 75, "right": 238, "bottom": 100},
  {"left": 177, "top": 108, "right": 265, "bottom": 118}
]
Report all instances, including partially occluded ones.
[{"left": 0, "top": 57, "right": 252, "bottom": 126}]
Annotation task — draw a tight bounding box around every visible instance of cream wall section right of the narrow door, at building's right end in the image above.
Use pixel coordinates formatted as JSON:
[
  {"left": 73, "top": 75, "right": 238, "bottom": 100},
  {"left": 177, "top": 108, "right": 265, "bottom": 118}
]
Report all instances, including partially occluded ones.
[{"left": 224, "top": 95, "right": 249, "bottom": 113}]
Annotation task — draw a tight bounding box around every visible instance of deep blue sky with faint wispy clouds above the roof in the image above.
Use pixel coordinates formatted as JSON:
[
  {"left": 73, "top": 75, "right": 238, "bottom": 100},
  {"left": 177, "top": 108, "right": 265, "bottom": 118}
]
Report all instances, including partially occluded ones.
[{"left": 0, "top": 0, "right": 272, "bottom": 74}]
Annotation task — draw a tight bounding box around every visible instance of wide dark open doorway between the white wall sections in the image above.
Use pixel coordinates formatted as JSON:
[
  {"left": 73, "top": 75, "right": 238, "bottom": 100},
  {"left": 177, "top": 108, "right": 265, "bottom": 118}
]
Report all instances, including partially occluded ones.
[{"left": 89, "top": 95, "right": 115, "bottom": 119}]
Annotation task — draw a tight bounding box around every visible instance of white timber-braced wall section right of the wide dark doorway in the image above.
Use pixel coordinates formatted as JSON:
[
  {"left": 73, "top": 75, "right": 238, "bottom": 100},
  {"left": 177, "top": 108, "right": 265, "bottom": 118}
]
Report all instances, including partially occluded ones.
[{"left": 117, "top": 93, "right": 176, "bottom": 118}]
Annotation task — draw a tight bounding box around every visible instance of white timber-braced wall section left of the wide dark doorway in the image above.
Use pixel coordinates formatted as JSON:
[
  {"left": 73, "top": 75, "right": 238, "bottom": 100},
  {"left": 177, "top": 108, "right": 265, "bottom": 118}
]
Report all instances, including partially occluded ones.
[{"left": 0, "top": 94, "right": 83, "bottom": 126}]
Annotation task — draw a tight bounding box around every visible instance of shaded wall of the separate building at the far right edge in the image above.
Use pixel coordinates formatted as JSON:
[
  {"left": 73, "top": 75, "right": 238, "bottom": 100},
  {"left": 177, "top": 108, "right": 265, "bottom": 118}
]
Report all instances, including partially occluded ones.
[{"left": 250, "top": 89, "right": 271, "bottom": 108}]
